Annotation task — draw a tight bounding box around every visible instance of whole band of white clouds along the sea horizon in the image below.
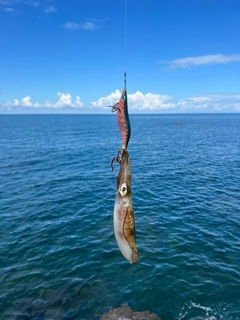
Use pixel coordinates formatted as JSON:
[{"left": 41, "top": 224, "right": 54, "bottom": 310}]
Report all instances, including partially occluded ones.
[{"left": 0, "top": 90, "right": 240, "bottom": 113}]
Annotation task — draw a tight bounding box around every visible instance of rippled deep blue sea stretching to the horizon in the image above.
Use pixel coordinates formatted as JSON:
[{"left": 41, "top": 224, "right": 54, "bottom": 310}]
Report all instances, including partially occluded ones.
[{"left": 0, "top": 114, "right": 240, "bottom": 320}]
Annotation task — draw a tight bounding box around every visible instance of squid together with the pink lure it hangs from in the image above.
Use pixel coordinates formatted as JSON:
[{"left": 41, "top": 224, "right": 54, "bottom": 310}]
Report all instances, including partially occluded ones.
[{"left": 111, "top": 74, "right": 138, "bottom": 263}]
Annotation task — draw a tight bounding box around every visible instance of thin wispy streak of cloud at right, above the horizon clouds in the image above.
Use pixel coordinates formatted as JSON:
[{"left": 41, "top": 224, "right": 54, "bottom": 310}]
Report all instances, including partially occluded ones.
[{"left": 160, "top": 54, "right": 240, "bottom": 69}]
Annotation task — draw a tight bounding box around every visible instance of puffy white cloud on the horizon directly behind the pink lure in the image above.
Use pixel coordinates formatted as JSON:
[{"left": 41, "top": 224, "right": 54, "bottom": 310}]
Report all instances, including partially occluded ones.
[{"left": 92, "top": 90, "right": 175, "bottom": 111}]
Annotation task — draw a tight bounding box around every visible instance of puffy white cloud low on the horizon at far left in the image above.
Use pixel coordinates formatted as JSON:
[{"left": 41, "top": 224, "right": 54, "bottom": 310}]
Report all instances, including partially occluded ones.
[{"left": 2, "top": 92, "right": 83, "bottom": 109}]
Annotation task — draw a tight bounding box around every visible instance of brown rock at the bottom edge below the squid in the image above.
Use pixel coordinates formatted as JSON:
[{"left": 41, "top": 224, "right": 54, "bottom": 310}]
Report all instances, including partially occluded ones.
[{"left": 100, "top": 305, "right": 161, "bottom": 320}]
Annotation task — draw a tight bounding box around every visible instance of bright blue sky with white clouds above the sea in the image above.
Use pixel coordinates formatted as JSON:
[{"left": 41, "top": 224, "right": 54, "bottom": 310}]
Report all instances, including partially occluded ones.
[{"left": 0, "top": 0, "right": 240, "bottom": 114}]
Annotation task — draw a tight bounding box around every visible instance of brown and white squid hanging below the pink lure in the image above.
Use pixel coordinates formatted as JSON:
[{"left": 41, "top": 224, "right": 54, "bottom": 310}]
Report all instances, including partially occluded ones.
[{"left": 111, "top": 148, "right": 138, "bottom": 263}]
